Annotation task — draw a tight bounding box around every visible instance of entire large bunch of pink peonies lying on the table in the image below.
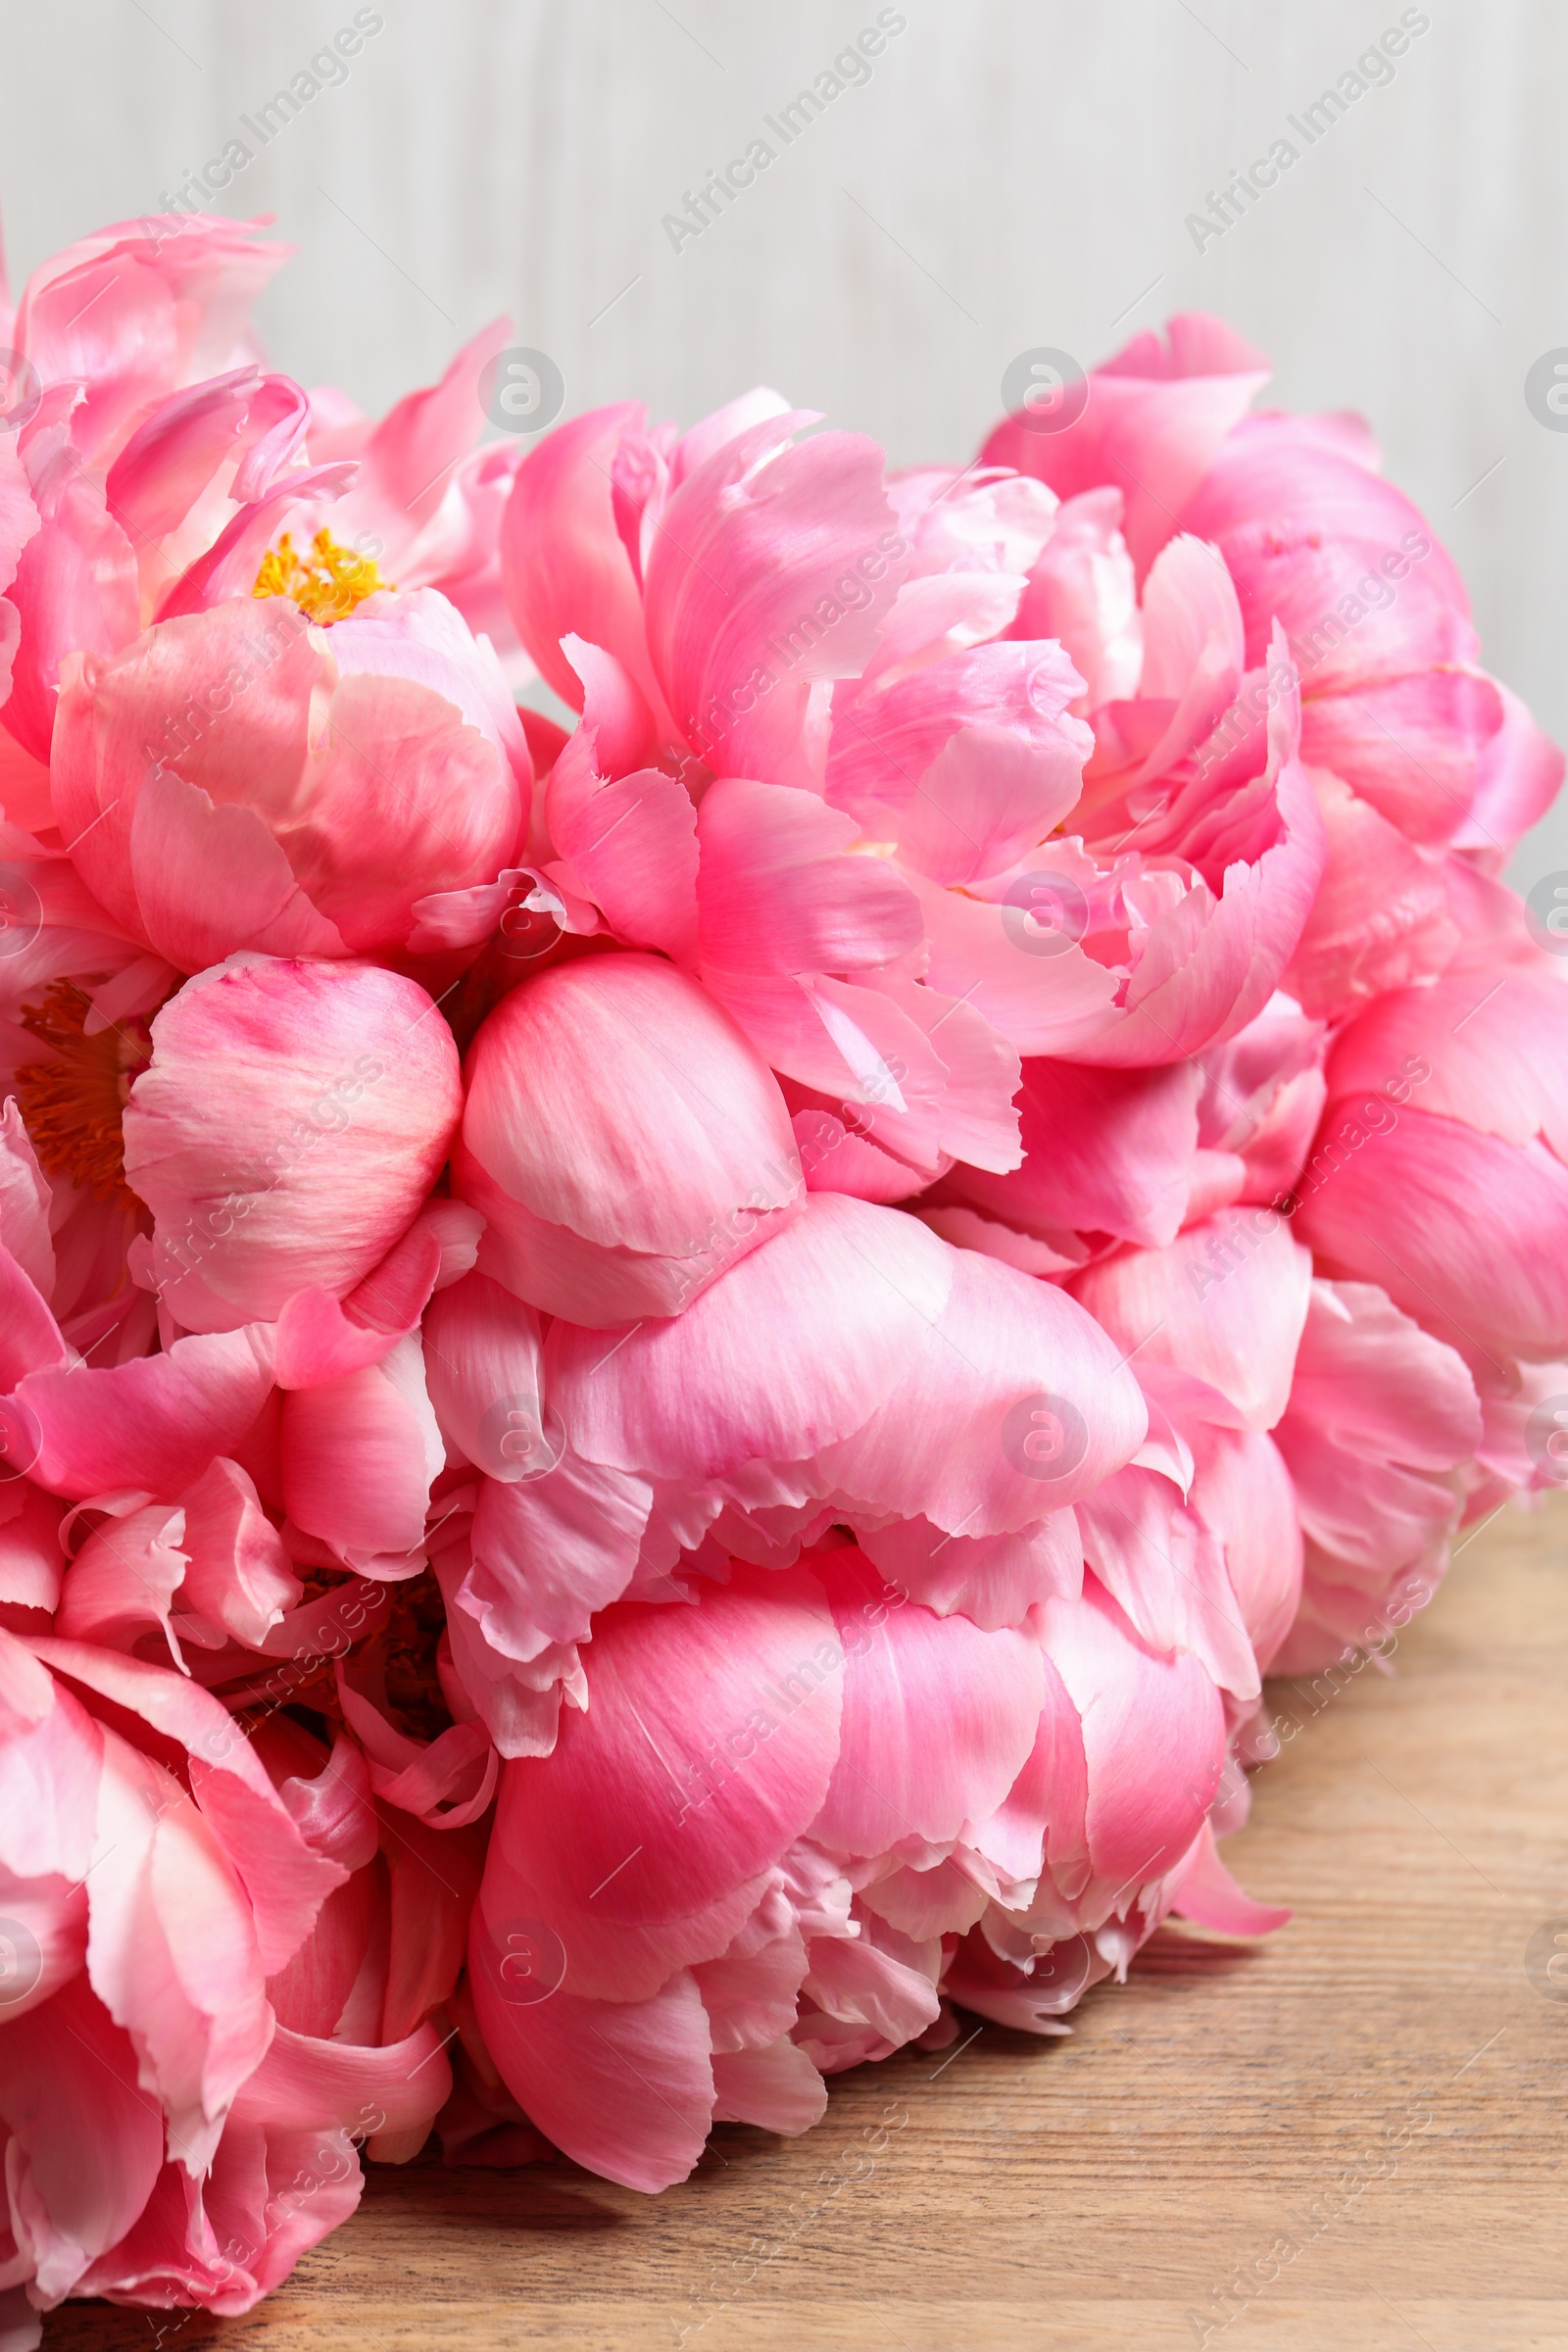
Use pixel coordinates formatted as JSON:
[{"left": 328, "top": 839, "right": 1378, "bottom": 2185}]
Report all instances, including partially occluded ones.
[{"left": 0, "top": 214, "right": 1568, "bottom": 2347}]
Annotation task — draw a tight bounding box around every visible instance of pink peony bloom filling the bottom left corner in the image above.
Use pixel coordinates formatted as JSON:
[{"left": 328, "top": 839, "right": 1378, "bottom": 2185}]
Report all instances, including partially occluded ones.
[{"left": 0, "top": 1633, "right": 461, "bottom": 2345}]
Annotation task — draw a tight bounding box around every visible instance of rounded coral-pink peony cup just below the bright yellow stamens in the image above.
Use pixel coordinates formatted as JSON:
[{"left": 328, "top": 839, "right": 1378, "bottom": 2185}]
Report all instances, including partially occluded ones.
[{"left": 52, "top": 590, "right": 529, "bottom": 971}]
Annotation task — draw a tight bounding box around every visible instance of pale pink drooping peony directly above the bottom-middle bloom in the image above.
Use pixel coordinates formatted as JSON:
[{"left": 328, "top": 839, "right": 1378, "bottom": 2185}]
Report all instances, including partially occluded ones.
[{"left": 416, "top": 1193, "right": 1148, "bottom": 1754}]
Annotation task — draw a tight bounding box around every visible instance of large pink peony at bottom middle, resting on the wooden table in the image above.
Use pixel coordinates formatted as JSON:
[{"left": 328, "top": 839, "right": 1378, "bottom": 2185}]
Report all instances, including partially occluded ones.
[{"left": 470, "top": 1545, "right": 1279, "bottom": 2189}]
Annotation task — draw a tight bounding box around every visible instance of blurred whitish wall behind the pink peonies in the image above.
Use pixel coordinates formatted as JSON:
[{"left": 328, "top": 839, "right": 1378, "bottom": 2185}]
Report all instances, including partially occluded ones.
[{"left": 0, "top": 0, "right": 1568, "bottom": 889}]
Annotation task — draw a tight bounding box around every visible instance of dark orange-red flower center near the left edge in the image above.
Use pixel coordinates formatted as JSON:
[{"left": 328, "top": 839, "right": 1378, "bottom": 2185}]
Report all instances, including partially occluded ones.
[{"left": 17, "top": 981, "right": 153, "bottom": 1200}]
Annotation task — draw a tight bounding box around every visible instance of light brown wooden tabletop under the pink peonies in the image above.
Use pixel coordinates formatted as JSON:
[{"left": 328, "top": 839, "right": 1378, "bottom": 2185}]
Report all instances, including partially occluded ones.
[{"left": 45, "top": 1498, "right": 1568, "bottom": 2352}]
